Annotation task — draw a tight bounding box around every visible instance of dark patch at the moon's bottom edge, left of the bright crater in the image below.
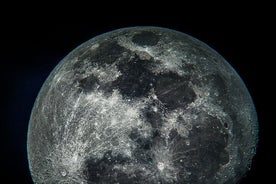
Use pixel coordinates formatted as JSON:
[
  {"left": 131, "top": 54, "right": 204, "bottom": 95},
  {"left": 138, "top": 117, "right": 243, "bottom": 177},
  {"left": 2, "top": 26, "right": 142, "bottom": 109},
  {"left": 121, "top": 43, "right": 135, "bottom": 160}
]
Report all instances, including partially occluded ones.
[{"left": 83, "top": 149, "right": 152, "bottom": 184}]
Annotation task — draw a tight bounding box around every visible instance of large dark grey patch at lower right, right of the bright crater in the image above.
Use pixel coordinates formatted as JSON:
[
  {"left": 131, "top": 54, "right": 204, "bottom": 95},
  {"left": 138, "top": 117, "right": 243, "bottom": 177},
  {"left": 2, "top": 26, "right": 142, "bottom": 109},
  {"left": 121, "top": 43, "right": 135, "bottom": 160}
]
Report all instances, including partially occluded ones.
[{"left": 175, "top": 115, "right": 229, "bottom": 184}]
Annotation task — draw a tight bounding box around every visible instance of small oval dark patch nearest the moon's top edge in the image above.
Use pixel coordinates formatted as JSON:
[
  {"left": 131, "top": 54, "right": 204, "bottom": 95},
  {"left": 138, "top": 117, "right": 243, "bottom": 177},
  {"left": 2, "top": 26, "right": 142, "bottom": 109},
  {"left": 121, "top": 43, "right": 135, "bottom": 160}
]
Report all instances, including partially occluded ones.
[{"left": 132, "top": 31, "right": 160, "bottom": 46}]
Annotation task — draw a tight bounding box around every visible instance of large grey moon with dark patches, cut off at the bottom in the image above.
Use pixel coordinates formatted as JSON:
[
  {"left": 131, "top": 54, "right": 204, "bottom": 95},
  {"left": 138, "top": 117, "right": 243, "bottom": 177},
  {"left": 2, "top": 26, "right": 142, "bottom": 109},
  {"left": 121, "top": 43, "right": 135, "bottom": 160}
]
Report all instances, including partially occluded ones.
[{"left": 27, "top": 27, "right": 258, "bottom": 184}]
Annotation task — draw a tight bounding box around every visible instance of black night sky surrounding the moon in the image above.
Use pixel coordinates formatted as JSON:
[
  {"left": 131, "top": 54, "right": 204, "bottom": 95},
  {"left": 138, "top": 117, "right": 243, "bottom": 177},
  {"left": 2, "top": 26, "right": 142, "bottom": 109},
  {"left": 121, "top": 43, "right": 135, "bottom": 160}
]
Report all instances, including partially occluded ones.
[{"left": 0, "top": 4, "right": 275, "bottom": 184}]
